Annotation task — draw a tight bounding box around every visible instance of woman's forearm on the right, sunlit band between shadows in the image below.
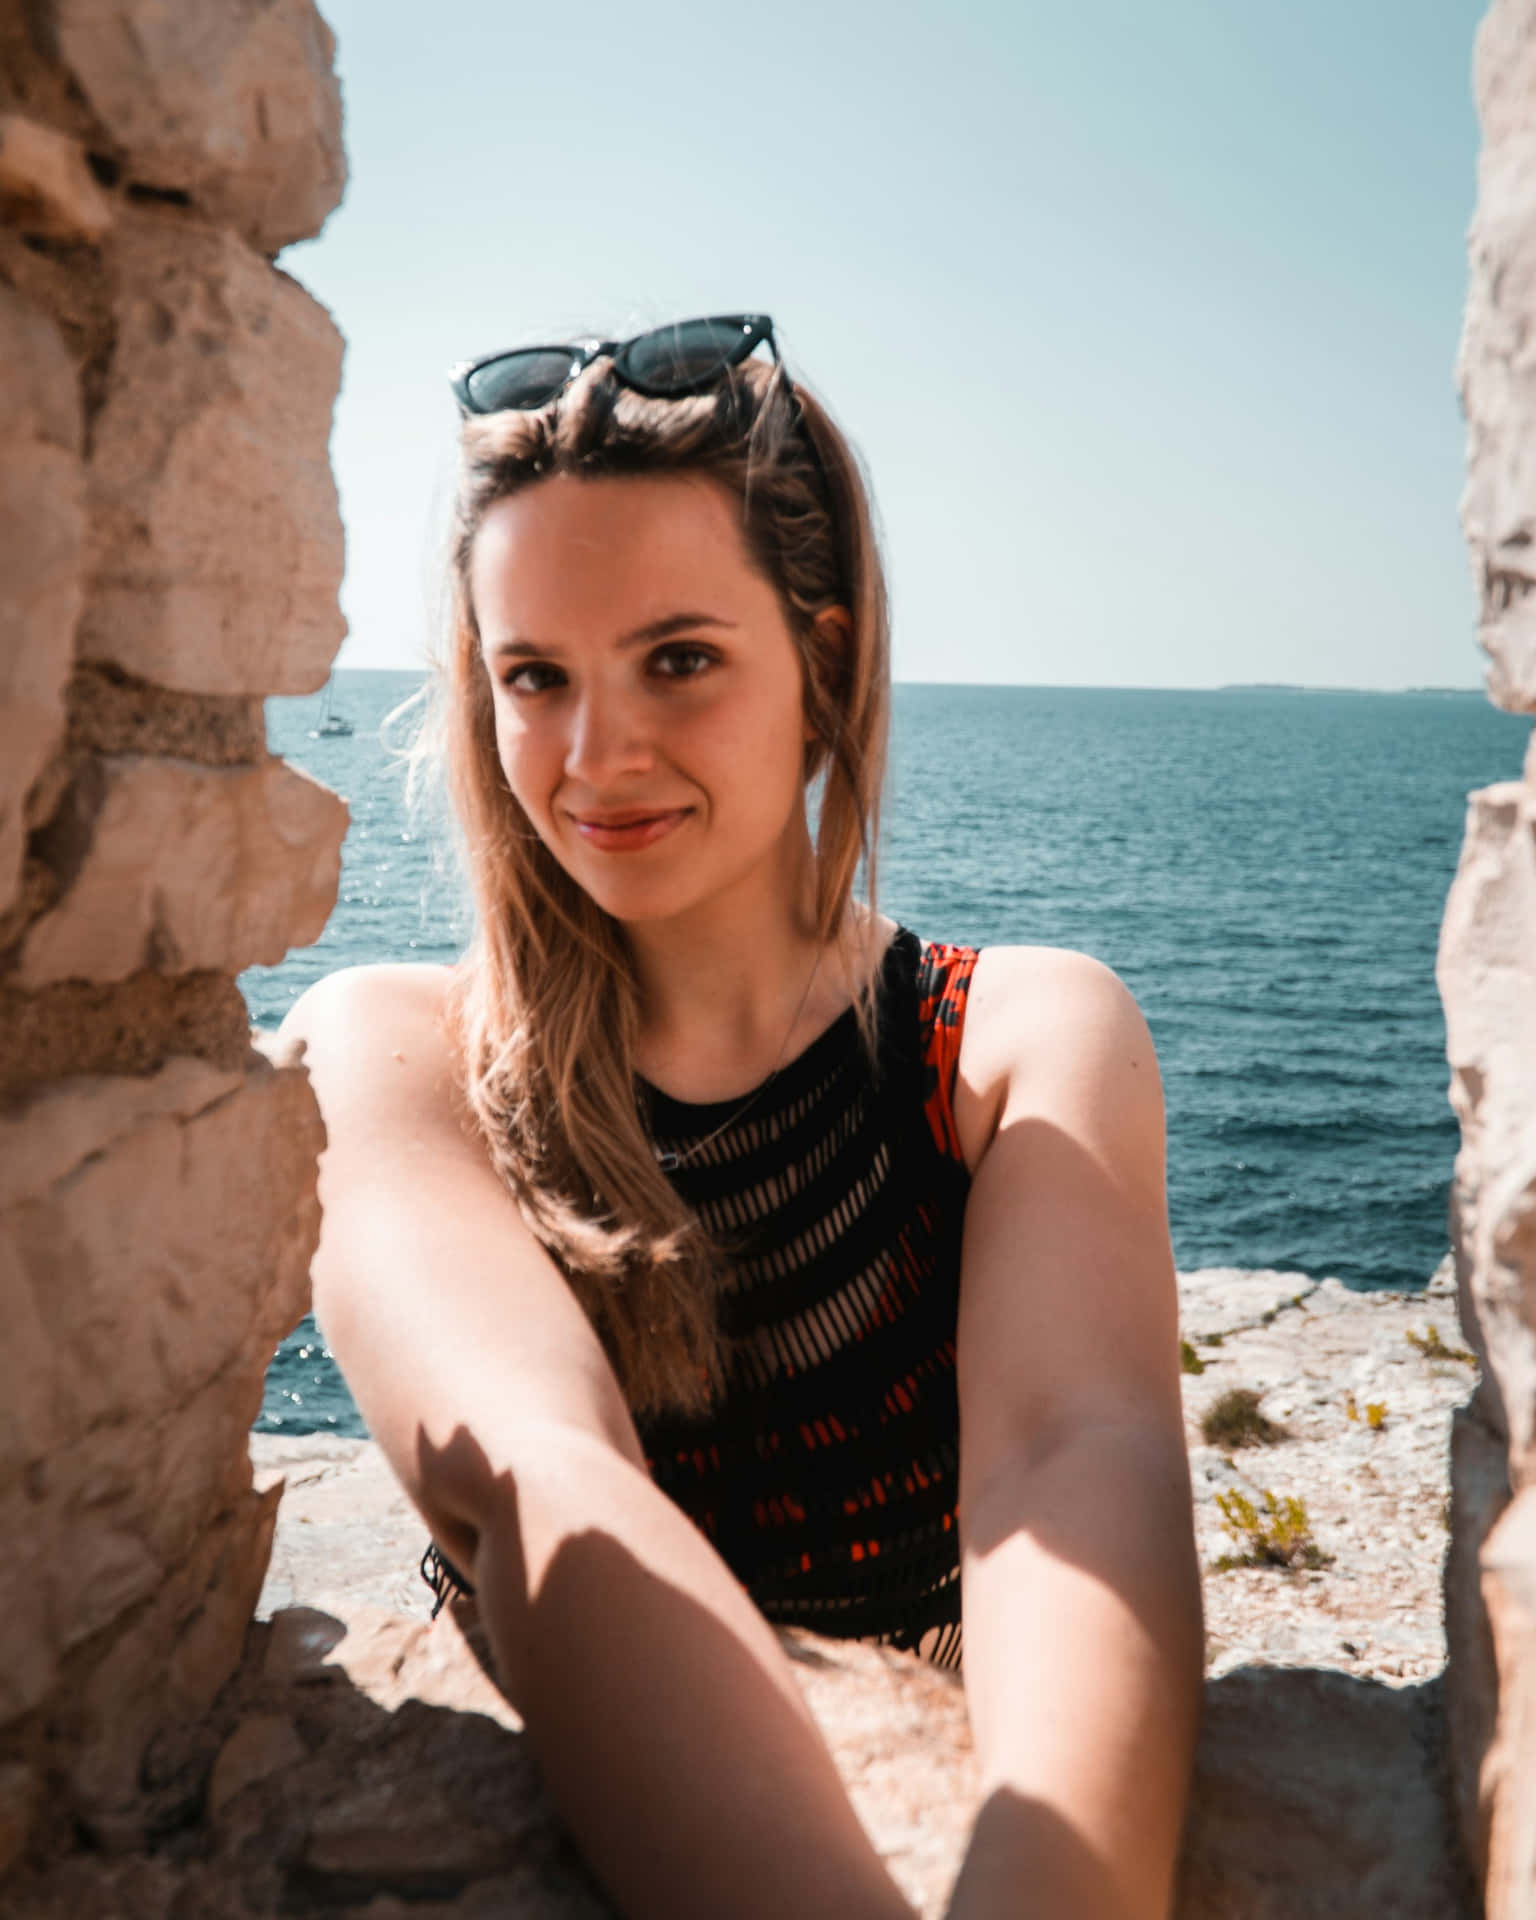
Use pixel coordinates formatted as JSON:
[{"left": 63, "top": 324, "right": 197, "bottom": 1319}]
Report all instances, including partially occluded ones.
[{"left": 950, "top": 1428, "right": 1204, "bottom": 1920}]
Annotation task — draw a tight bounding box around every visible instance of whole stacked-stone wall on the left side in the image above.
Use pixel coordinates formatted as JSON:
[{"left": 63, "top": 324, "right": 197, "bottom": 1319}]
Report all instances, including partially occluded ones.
[{"left": 0, "top": 0, "right": 346, "bottom": 1874}]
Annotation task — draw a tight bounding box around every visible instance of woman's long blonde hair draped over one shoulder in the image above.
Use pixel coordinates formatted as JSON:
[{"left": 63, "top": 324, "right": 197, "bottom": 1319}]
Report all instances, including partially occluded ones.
[{"left": 432, "top": 345, "right": 889, "bottom": 1413}]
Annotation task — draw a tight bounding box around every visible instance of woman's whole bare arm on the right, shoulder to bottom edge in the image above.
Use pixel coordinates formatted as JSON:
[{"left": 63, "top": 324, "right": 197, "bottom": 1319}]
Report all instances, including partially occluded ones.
[{"left": 950, "top": 948, "right": 1204, "bottom": 1920}]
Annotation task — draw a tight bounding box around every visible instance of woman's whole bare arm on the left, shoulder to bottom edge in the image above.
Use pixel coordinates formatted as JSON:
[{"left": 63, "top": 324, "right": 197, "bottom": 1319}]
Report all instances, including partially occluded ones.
[{"left": 284, "top": 968, "right": 910, "bottom": 1920}]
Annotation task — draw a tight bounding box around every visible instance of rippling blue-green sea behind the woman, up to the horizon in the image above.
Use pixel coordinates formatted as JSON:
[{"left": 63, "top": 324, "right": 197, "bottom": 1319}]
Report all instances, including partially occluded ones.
[{"left": 242, "top": 672, "right": 1530, "bottom": 1434}]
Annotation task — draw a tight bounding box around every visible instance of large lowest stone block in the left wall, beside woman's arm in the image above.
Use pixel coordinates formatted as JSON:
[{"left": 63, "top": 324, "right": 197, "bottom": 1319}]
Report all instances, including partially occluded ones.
[{"left": 0, "top": 1060, "right": 323, "bottom": 1834}]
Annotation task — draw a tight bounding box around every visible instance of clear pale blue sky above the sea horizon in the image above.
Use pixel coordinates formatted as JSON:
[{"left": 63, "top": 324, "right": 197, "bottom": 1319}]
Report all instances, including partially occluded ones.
[{"left": 282, "top": 0, "right": 1482, "bottom": 687}]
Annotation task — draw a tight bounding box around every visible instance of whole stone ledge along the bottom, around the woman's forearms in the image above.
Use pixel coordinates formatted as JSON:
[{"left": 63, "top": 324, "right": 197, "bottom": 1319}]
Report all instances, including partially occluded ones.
[{"left": 8, "top": 1607, "right": 1473, "bottom": 1920}]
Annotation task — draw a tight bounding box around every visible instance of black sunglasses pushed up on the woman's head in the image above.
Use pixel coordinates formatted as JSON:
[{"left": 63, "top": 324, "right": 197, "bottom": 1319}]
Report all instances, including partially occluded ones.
[{"left": 449, "top": 313, "right": 779, "bottom": 415}]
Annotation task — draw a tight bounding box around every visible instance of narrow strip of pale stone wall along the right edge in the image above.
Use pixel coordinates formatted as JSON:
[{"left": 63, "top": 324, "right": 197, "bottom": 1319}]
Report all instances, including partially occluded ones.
[{"left": 1440, "top": 0, "right": 1536, "bottom": 1920}]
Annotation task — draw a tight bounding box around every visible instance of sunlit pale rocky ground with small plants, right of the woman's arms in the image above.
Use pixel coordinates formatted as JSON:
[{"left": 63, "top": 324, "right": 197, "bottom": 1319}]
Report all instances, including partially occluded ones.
[{"left": 1181, "top": 1269, "right": 1476, "bottom": 1680}]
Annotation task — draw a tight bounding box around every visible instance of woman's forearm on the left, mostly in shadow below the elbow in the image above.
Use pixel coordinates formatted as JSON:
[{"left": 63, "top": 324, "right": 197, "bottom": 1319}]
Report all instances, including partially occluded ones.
[{"left": 462, "top": 1428, "right": 910, "bottom": 1920}]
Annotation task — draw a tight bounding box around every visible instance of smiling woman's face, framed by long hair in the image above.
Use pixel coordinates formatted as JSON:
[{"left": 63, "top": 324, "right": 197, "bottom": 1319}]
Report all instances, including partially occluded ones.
[{"left": 470, "top": 474, "right": 829, "bottom": 922}]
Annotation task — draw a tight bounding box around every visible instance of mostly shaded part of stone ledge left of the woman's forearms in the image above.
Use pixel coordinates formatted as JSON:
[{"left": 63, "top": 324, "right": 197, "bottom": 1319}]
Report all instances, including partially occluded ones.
[{"left": 6, "top": 1607, "right": 614, "bottom": 1920}]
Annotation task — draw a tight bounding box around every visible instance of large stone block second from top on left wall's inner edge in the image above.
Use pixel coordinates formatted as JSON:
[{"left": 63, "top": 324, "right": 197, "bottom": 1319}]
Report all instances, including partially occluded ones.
[{"left": 77, "top": 209, "right": 346, "bottom": 693}]
